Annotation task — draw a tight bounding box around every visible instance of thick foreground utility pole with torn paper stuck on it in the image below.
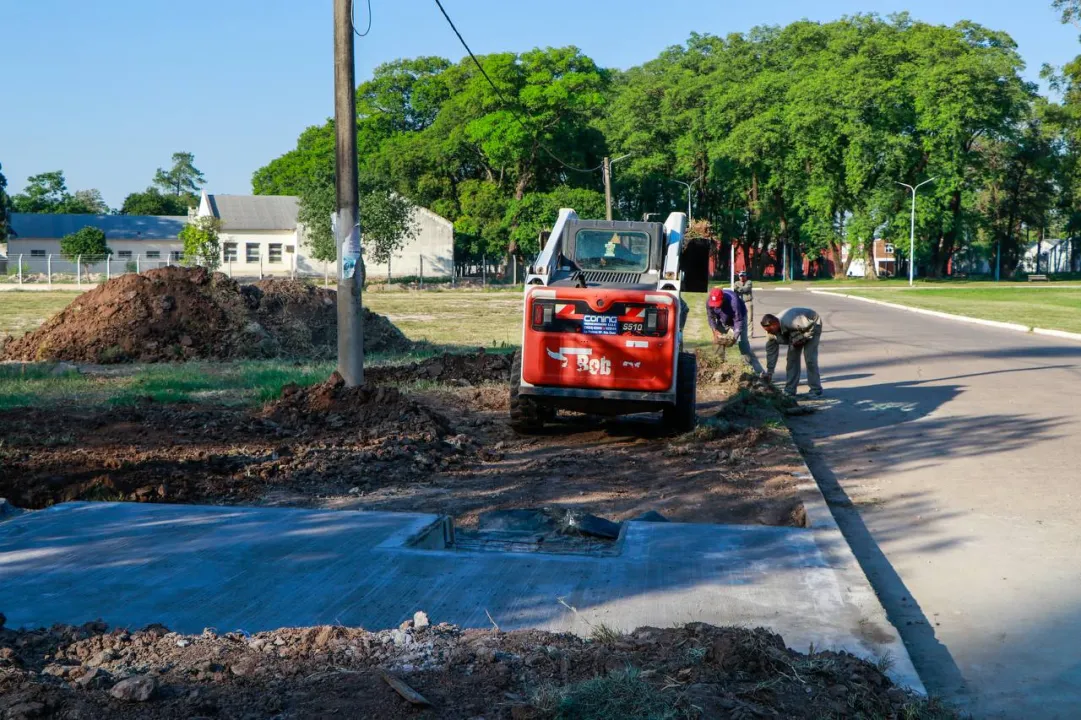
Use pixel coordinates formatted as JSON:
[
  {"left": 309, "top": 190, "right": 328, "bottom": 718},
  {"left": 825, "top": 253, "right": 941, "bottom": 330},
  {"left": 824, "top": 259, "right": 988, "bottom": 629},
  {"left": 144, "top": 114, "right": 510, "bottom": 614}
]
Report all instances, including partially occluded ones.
[{"left": 334, "top": 0, "right": 364, "bottom": 387}]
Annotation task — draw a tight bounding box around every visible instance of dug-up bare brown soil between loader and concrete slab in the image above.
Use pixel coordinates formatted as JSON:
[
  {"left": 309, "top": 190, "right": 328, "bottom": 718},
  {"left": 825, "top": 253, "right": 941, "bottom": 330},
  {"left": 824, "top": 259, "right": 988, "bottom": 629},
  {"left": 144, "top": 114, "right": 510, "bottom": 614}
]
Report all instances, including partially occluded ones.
[{"left": 0, "top": 351, "right": 804, "bottom": 526}]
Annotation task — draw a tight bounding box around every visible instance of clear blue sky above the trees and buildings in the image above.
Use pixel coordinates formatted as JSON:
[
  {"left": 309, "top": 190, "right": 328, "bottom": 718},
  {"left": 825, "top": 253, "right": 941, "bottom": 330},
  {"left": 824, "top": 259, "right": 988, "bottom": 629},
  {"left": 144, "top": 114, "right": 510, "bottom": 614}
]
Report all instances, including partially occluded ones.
[{"left": 0, "top": 0, "right": 1081, "bottom": 206}]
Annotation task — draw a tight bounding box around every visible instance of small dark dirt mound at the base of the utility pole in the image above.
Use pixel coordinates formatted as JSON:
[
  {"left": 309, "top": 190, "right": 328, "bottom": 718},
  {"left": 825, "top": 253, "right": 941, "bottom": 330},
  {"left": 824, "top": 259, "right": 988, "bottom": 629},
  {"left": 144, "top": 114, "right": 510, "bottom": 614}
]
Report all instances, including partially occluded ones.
[{"left": 264, "top": 372, "right": 451, "bottom": 442}]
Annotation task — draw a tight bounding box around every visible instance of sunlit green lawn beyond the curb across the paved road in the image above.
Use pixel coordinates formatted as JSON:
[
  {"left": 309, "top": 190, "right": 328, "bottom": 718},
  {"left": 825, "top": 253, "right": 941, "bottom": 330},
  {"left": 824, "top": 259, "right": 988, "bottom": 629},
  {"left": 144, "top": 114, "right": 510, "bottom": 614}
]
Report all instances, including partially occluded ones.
[{"left": 846, "top": 286, "right": 1081, "bottom": 333}]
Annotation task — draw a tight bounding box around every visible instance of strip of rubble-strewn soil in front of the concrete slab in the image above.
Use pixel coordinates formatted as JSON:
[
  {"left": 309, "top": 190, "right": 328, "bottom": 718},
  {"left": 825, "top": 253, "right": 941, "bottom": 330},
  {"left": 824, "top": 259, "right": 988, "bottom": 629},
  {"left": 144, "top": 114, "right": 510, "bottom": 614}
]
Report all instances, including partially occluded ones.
[{"left": 0, "top": 613, "right": 958, "bottom": 720}]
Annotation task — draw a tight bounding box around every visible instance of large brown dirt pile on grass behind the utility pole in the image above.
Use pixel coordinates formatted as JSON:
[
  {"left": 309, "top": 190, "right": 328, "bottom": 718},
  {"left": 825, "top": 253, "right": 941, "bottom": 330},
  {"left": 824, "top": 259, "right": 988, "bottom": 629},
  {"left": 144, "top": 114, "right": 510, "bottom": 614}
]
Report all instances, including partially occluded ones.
[{"left": 0, "top": 267, "right": 412, "bottom": 363}]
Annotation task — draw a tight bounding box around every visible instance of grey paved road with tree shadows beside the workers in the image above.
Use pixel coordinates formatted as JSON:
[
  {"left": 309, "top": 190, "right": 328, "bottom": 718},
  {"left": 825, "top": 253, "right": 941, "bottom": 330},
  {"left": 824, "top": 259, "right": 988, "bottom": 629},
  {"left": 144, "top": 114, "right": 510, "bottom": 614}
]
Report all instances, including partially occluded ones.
[{"left": 757, "top": 292, "right": 1081, "bottom": 719}]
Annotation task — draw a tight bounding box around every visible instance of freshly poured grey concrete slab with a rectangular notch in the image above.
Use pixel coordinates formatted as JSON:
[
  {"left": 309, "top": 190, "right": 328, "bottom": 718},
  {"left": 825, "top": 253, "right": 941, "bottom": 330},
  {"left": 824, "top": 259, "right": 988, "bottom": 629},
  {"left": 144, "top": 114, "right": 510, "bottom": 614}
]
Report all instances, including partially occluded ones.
[{"left": 0, "top": 503, "right": 922, "bottom": 690}]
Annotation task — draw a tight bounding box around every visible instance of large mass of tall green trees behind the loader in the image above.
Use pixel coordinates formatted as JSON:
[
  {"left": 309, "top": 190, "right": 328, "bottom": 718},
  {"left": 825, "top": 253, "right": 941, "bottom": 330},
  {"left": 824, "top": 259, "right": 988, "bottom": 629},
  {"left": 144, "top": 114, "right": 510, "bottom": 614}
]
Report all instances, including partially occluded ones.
[{"left": 238, "top": 14, "right": 1081, "bottom": 275}]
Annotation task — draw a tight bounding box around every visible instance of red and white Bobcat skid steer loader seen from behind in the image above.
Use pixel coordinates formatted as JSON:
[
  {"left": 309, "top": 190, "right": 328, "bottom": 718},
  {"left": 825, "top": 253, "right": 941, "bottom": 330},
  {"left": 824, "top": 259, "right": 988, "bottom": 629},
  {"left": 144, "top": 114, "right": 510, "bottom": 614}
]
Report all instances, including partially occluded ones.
[{"left": 510, "top": 209, "right": 709, "bottom": 432}]
